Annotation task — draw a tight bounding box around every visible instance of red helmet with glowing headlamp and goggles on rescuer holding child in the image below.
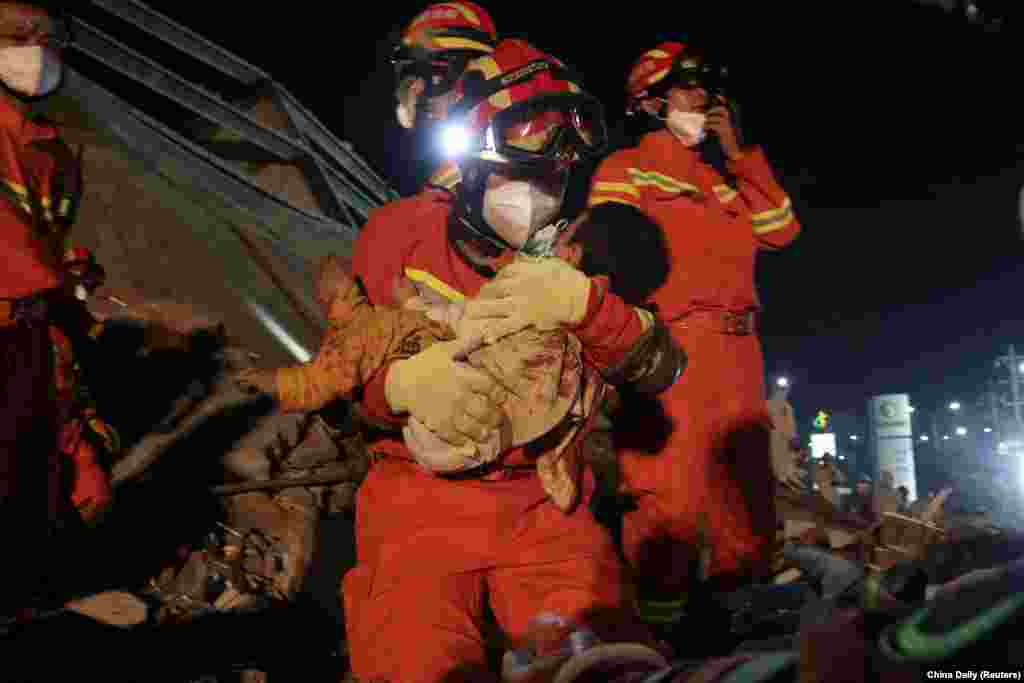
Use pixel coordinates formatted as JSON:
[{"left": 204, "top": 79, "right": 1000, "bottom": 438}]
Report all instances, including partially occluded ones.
[{"left": 444, "top": 40, "right": 607, "bottom": 249}]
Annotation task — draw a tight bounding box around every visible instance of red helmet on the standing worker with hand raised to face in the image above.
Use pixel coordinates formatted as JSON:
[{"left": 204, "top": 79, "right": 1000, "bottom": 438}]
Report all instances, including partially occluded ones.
[{"left": 626, "top": 42, "right": 726, "bottom": 113}]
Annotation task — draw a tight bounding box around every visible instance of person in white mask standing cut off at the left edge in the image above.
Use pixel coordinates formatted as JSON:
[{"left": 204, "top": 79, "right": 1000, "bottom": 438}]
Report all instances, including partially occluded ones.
[{"left": 0, "top": 2, "right": 80, "bottom": 613}]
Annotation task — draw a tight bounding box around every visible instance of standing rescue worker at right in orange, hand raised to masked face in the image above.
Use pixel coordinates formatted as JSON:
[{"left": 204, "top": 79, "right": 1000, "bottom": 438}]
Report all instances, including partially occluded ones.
[{"left": 466, "top": 43, "right": 799, "bottom": 617}]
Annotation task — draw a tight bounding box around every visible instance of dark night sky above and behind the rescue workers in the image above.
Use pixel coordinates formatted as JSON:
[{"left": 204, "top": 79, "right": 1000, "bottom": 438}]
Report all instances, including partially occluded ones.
[{"left": 140, "top": 0, "right": 1024, "bottom": 423}]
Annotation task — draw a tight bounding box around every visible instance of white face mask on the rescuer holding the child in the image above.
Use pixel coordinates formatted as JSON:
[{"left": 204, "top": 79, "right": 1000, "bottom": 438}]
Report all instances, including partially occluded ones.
[{"left": 483, "top": 180, "right": 562, "bottom": 248}]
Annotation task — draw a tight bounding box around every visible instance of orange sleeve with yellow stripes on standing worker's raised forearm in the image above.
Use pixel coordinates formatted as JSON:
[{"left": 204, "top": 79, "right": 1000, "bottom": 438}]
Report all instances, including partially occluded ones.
[{"left": 728, "top": 147, "right": 800, "bottom": 249}]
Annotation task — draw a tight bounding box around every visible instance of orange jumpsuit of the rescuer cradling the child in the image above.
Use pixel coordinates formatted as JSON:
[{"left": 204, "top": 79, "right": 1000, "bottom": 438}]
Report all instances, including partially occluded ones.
[{"left": 342, "top": 189, "right": 642, "bottom": 683}]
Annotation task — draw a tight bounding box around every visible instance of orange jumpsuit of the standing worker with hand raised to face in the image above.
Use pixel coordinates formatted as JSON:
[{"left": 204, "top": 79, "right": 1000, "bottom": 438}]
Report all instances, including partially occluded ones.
[{"left": 588, "top": 130, "right": 800, "bottom": 592}]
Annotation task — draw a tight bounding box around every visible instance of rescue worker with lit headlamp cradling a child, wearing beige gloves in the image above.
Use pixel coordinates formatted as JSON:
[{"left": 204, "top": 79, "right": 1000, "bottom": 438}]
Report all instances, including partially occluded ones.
[{"left": 343, "top": 41, "right": 678, "bottom": 683}]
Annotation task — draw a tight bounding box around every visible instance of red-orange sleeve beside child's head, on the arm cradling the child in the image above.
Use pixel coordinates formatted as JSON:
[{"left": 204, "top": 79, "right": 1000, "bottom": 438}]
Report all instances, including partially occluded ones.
[{"left": 572, "top": 276, "right": 646, "bottom": 372}]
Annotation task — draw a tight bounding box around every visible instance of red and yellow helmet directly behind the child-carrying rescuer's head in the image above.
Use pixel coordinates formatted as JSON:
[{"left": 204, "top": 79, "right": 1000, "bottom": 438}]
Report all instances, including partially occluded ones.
[{"left": 391, "top": 2, "right": 498, "bottom": 96}]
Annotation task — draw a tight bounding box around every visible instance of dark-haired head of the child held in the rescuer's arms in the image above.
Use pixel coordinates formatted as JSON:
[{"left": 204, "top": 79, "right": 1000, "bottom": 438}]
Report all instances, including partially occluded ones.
[{"left": 562, "top": 204, "right": 670, "bottom": 306}]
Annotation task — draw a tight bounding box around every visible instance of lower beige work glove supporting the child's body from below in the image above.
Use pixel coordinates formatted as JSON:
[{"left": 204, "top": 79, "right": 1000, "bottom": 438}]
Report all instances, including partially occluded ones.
[{"left": 384, "top": 340, "right": 507, "bottom": 445}]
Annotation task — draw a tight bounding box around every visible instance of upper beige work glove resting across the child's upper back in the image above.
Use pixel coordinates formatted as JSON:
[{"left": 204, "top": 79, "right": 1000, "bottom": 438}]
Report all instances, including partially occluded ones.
[{"left": 456, "top": 256, "right": 591, "bottom": 344}]
